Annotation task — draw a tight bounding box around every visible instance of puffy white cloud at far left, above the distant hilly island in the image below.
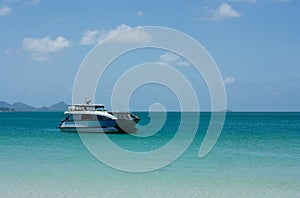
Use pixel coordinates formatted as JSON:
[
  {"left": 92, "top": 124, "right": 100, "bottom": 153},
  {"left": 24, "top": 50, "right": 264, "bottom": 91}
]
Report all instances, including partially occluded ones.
[{"left": 23, "top": 36, "right": 72, "bottom": 61}]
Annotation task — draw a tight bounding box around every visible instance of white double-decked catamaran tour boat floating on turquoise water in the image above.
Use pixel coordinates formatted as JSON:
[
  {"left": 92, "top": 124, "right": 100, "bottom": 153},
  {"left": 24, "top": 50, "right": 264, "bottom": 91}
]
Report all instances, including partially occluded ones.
[{"left": 58, "top": 100, "right": 140, "bottom": 133}]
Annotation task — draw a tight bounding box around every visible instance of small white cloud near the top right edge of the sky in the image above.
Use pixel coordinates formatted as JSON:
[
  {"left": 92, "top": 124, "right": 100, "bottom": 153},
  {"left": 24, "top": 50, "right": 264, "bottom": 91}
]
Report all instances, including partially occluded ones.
[{"left": 198, "top": 3, "right": 241, "bottom": 21}]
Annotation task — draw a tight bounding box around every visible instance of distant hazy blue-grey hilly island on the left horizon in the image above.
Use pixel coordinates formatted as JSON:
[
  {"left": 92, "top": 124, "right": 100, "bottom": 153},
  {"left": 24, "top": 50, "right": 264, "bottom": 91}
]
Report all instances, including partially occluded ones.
[{"left": 0, "top": 101, "right": 68, "bottom": 112}]
